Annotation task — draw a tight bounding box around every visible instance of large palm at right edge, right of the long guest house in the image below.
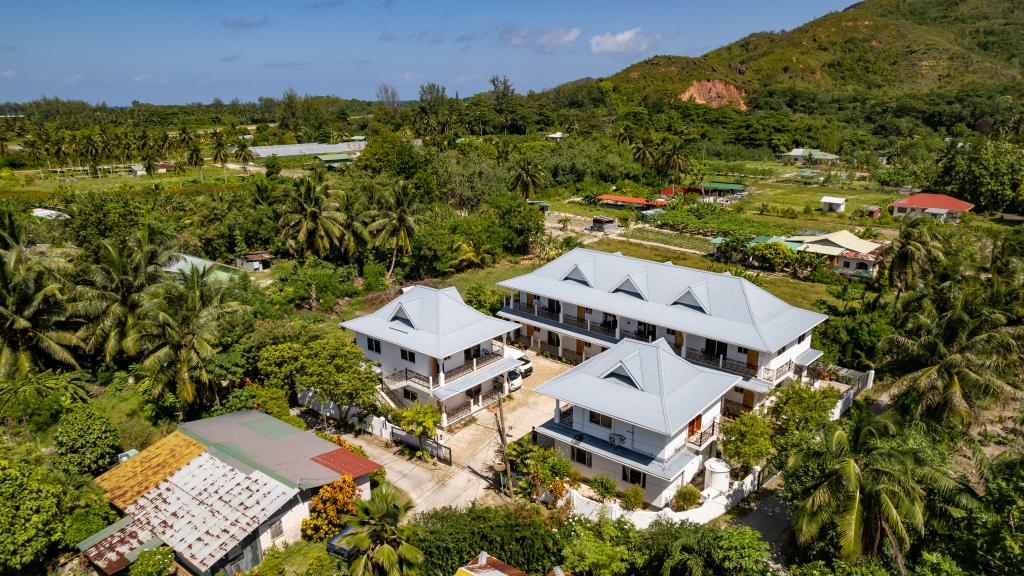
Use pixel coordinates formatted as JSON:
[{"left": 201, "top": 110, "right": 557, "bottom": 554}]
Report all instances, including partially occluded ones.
[{"left": 881, "top": 283, "right": 1024, "bottom": 426}]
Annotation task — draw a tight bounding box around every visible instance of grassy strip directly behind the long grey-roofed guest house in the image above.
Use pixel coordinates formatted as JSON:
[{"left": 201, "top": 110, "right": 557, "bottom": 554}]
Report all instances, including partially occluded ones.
[{"left": 587, "top": 238, "right": 838, "bottom": 310}]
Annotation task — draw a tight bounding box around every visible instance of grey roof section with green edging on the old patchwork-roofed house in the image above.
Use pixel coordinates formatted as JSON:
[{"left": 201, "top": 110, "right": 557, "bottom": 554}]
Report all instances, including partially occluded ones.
[{"left": 178, "top": 410, "right": 374, "bottom": 488}]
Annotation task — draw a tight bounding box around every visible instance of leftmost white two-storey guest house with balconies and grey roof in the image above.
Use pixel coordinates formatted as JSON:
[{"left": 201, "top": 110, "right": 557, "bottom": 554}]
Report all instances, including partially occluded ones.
[{"left": 341, "top": 286, "right": 520, "bottom": 427}]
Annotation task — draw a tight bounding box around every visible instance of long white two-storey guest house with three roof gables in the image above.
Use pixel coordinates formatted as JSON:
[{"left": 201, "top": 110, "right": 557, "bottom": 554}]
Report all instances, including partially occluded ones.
[{"left": 499, "top": 248, "right": 826, "bottom": 414}]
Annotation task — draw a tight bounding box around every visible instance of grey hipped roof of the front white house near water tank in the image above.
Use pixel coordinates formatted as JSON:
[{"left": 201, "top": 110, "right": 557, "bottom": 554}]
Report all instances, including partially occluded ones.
[{"left": 537, "top": 339, "right": 741, "bottom": 436}]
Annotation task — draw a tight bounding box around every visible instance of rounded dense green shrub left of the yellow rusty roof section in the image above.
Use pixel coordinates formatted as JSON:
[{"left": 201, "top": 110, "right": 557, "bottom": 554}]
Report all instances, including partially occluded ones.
[{"left": 53, "top": 404, "right": 121, "bottom": 475}]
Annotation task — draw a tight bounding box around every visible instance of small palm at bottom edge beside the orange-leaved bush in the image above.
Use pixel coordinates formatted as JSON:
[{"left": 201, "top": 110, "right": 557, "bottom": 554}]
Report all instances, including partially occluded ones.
[{"left": 338, "top": 483, "right": 424, "bottom": 576}]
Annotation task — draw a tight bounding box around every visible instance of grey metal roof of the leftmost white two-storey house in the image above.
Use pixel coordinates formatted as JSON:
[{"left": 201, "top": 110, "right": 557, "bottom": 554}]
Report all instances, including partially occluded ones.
[{"left": 341, "top": 286, "right": 519, "bottom": 359}]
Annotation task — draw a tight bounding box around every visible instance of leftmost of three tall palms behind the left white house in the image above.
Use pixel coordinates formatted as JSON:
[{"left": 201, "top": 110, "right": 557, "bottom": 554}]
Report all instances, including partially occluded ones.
[{"left": 280, "top": 178, "right": 345, "bottom": 257}]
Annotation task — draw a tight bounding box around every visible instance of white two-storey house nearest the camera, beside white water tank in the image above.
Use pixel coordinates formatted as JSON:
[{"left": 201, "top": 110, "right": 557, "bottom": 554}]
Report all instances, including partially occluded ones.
[{"left": 536, "top": 339, "right": 741, "bottom": 507}]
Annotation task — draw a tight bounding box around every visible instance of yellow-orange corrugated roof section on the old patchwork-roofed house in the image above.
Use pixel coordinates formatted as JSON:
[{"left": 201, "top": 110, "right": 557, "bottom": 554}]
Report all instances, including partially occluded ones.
[{"left": 96, "top": 431, "right": 206, "bottom": 510}]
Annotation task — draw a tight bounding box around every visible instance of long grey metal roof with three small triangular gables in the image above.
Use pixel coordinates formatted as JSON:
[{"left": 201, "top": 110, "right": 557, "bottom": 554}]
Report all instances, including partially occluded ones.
[{"left": 498, "top": 248, "right": 827, "bottom": 353}]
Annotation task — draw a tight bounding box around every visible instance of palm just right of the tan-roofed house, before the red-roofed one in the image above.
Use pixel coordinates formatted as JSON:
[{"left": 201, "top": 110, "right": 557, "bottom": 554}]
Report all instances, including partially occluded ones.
[{"left": 881, "top": 218, "right": 944, "bottom": 316}]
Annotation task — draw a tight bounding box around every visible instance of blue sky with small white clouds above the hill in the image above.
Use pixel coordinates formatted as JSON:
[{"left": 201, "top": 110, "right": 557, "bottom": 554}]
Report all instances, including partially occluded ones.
[{"left": 0, "top": 0, "right": 852, "bottom": 105}]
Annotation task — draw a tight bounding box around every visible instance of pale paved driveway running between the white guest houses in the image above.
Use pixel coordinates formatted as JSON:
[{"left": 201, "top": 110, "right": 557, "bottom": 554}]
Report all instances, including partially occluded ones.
[{"left": 353, "top": 352, "right": 568, "bottom": 510}]
